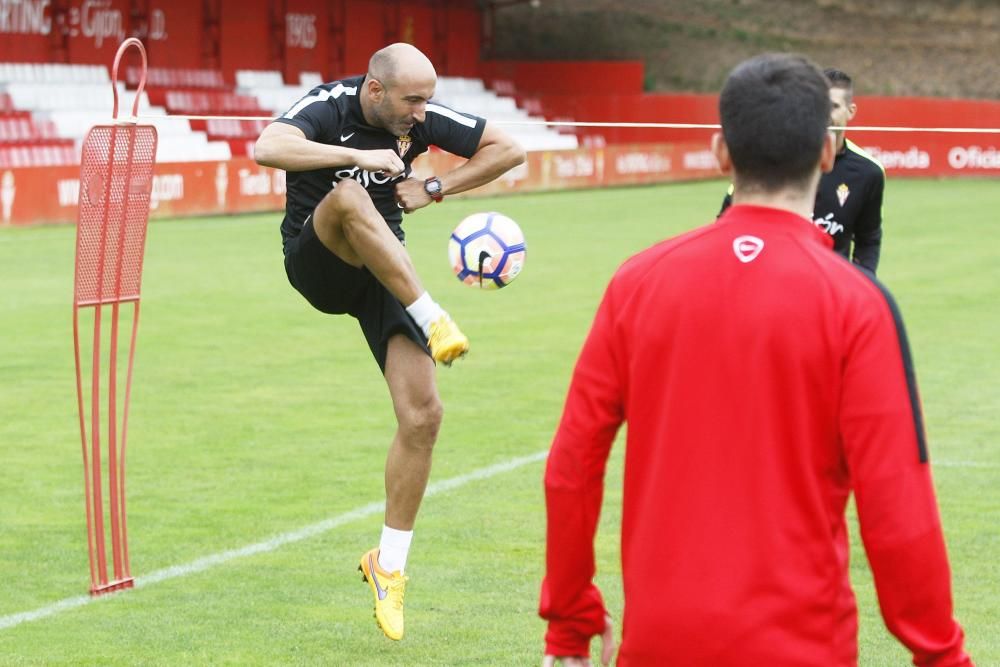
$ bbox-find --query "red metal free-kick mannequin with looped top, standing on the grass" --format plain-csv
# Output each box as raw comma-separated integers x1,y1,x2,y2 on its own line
73,38,157,595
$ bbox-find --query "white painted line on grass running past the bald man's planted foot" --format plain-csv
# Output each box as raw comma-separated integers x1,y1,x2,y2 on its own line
0,450,548,630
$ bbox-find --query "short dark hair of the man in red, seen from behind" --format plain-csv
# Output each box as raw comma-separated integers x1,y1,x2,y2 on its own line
719,53,830,192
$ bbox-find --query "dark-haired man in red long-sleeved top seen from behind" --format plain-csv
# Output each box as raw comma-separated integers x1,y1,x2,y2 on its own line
539,54,972,667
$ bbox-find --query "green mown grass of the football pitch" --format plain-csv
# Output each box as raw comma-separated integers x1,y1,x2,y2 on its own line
0,179,1000,665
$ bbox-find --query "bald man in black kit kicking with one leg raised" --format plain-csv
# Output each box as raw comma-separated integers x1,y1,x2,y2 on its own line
254,43,524,640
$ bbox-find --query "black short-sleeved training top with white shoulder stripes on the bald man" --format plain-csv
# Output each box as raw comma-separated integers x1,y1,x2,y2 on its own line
275,76,486,241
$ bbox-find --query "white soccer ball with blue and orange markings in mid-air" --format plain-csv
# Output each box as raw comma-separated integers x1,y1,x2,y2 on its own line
448,212,527,289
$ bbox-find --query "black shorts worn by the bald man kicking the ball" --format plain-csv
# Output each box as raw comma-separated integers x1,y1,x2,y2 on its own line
284,216,430,373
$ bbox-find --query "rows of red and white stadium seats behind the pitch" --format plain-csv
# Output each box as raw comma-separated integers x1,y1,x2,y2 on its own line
0,63,578,166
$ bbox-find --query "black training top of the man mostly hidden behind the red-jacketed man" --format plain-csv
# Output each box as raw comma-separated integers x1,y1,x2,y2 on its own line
720,140,885,273
